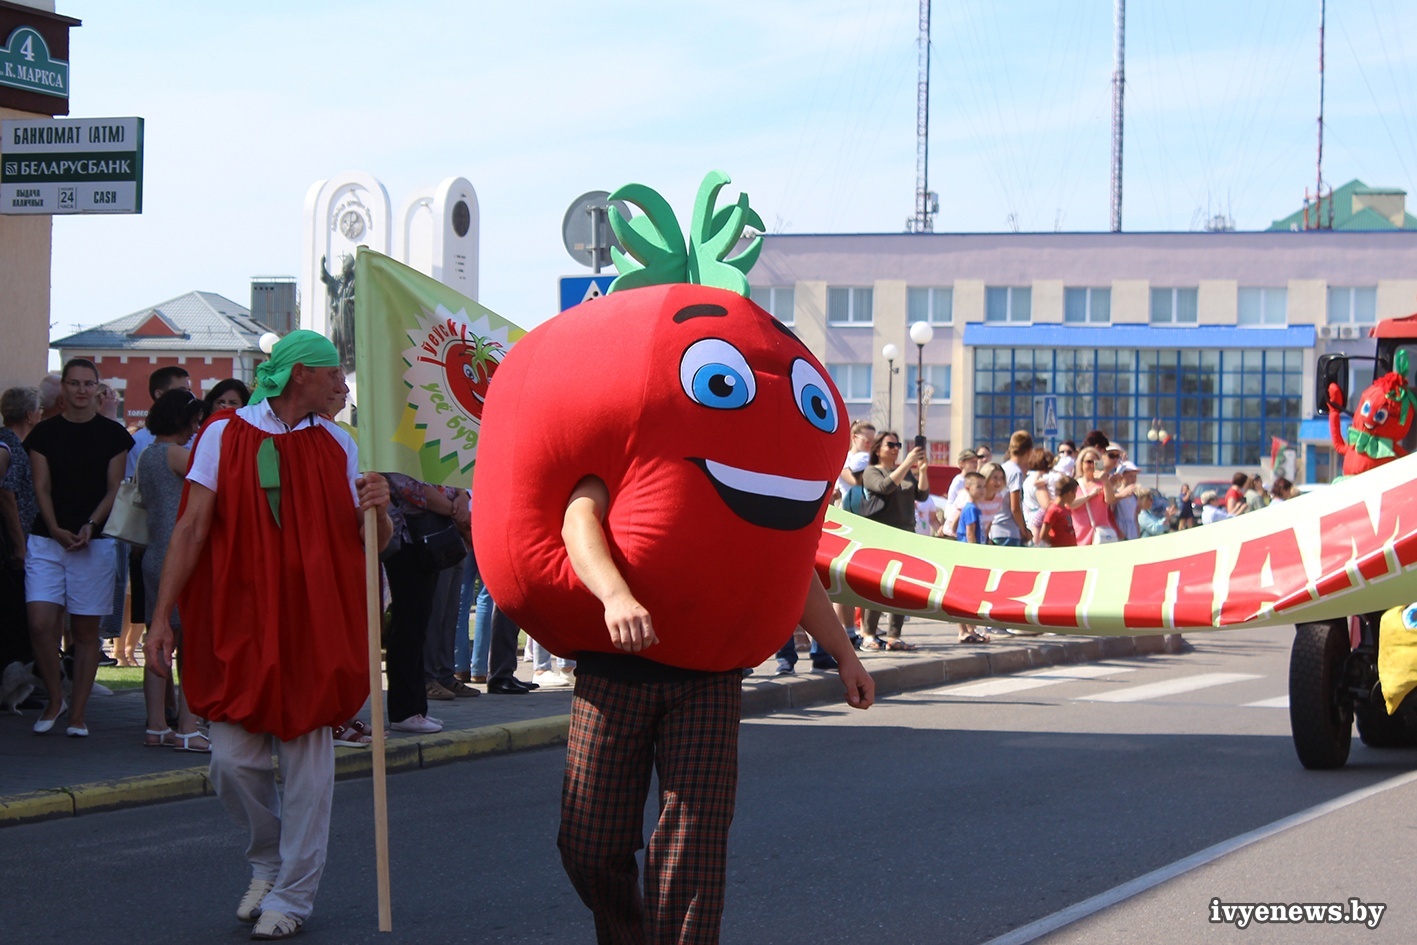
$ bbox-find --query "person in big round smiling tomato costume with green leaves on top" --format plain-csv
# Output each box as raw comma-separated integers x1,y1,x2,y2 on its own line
473,171,874,942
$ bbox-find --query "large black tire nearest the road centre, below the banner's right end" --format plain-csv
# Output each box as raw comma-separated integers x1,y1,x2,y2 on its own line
1289,621,1353,769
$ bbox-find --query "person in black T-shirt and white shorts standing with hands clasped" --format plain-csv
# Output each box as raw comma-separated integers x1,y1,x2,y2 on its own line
24,358,133,738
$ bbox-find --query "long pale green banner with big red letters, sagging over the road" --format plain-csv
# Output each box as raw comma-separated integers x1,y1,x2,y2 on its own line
816,456,1417,635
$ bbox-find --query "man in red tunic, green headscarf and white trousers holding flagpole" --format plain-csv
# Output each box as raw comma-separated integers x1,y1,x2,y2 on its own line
145,330,393,939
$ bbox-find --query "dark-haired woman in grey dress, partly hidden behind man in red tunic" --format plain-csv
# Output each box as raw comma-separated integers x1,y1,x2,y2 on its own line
135,388,211,754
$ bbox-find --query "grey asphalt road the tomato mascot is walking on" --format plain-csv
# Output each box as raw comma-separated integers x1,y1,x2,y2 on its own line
0,630,1417,945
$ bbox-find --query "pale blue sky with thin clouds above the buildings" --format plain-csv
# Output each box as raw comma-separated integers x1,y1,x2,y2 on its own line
44,0,1417,337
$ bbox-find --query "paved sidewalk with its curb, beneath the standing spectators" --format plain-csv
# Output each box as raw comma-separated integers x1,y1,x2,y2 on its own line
0,621,1185,827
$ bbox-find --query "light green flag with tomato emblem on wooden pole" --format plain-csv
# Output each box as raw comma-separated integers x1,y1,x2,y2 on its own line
354,247,526,487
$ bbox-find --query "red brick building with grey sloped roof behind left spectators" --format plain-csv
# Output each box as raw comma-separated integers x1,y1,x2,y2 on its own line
50,292,269,428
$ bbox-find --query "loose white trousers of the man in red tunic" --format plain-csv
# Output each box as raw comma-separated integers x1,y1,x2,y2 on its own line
210,723,334,922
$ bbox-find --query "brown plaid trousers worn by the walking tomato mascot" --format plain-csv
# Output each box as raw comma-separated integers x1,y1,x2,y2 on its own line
557,672,743,945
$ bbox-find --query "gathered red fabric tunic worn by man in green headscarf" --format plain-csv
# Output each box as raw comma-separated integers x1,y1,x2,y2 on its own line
177,417,368,741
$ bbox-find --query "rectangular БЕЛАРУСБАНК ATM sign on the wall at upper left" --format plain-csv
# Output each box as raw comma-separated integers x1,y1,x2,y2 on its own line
0,118,143,214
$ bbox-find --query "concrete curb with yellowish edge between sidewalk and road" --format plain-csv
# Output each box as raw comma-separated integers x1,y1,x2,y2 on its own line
0,633,1189,829
